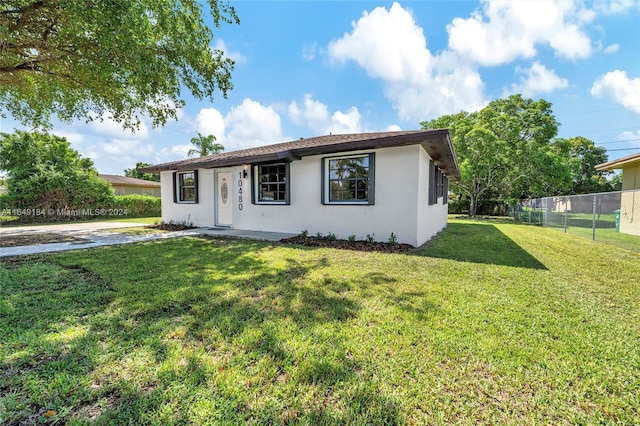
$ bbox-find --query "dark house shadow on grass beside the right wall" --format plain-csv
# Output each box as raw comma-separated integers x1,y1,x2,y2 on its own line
413,223,547,269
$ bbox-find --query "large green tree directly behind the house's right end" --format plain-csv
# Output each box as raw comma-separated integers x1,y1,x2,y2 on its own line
420,95,570,216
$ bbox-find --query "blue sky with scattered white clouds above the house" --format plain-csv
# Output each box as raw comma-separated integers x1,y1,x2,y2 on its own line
0,0,640,174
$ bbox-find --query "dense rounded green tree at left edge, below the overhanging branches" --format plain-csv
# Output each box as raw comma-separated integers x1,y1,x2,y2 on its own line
0,130,113,216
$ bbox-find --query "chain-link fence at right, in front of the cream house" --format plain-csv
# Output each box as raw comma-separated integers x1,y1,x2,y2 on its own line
510,190,640,252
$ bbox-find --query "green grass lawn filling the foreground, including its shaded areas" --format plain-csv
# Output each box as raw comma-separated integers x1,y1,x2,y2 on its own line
0,220,640,425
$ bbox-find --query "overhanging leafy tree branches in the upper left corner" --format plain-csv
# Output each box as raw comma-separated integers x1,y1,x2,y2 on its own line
0,0,239,129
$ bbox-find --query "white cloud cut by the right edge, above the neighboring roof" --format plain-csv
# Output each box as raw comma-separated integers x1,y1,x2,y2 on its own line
591,70,640,114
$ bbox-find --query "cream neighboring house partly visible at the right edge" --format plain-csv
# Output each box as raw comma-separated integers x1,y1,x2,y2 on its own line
596,153,640,235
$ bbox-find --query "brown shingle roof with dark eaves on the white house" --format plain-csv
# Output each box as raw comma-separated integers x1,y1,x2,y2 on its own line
140,129,460,180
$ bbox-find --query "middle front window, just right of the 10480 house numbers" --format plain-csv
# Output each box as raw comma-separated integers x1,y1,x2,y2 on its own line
253,163,289,204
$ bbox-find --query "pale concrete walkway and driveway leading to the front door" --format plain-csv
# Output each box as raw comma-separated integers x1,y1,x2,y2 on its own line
0,222,295,257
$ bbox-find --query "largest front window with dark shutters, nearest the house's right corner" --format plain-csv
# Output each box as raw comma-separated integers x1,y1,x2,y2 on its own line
322,153,375,204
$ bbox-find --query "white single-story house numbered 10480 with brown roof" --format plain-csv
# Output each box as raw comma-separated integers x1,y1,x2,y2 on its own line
140,130,460,246
